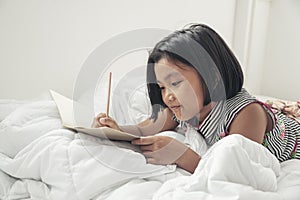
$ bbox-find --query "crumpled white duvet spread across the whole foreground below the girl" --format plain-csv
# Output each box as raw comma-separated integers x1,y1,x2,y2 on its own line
0,101,300,200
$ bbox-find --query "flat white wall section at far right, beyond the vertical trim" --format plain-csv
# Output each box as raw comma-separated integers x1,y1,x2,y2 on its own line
261,0,300,101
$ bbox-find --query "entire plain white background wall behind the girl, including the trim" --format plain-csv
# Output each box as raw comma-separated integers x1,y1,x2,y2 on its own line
0,0,300,100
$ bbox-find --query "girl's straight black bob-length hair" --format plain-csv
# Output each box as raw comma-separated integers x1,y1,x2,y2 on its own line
147,24,244,120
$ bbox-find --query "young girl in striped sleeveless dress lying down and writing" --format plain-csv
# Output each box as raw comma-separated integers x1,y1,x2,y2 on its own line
93,24,300,173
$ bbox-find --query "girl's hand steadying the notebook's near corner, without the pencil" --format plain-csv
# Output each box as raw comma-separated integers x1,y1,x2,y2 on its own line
131,136,188,165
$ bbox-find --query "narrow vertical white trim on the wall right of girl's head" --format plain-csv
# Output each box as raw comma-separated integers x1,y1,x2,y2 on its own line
236,0,271,94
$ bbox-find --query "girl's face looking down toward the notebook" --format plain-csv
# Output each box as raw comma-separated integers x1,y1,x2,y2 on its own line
154,58,204,121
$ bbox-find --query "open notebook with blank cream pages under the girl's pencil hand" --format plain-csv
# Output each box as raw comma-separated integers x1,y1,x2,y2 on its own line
50,90,139,141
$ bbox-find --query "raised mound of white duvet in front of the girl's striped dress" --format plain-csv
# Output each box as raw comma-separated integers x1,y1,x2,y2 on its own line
154,134,281,200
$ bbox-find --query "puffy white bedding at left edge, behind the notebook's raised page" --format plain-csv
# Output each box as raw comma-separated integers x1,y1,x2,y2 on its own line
0,100,61,157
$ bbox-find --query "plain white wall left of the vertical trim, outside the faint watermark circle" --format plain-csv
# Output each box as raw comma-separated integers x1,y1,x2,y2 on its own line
0,0,235,99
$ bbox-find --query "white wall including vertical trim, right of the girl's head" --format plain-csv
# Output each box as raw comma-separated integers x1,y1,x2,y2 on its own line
241,0,300,101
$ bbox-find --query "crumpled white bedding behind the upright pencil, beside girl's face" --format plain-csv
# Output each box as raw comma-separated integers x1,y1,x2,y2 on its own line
92,77,151,125
